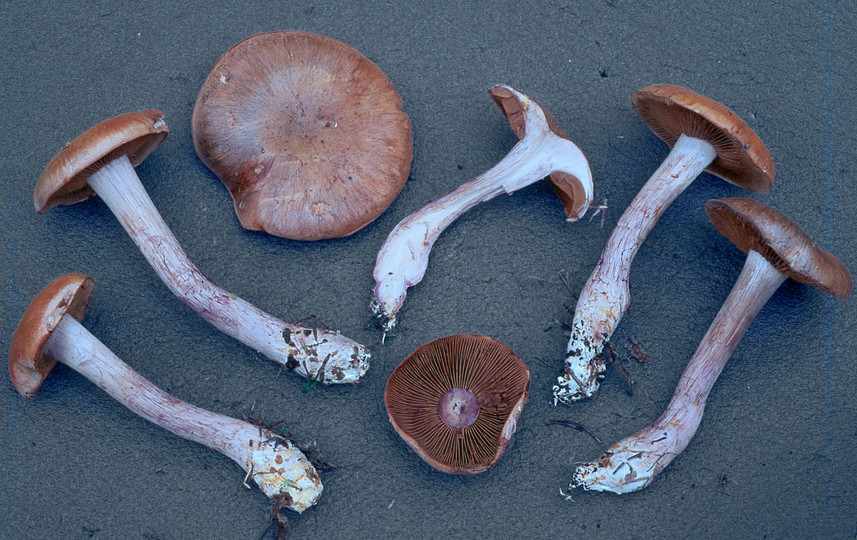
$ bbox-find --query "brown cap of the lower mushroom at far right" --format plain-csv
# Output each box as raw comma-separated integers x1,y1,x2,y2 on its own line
705,197,851,298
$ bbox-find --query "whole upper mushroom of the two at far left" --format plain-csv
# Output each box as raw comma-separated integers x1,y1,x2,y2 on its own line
33,110,369,384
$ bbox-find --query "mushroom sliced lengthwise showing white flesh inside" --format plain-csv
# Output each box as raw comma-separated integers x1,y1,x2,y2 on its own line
371,85,592,335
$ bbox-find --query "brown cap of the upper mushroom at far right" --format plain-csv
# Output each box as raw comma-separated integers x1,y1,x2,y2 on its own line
631,84,774,193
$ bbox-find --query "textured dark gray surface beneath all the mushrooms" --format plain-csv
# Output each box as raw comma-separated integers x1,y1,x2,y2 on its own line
0,0,857,539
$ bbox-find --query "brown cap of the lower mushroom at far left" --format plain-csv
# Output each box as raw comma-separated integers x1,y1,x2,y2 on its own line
9,274,95,397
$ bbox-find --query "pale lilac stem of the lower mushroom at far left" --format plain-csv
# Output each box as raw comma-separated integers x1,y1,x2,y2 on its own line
45,315,322,512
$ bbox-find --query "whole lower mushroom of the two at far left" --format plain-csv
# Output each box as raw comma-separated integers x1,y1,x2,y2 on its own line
9,274,322,512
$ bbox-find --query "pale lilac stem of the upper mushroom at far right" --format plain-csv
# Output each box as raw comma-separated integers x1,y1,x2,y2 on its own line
553,135,717,405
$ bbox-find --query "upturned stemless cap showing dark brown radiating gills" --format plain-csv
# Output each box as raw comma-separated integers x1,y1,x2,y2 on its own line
384,335,530,474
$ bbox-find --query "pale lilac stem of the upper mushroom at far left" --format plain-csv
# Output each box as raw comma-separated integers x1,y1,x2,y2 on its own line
87,155,369,384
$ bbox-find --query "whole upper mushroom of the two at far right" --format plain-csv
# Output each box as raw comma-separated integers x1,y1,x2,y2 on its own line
553,84,774,405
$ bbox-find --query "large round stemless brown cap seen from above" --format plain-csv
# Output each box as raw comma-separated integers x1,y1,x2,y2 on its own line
192,32,413,240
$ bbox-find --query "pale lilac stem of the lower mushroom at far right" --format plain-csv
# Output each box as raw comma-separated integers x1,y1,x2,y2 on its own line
570,251,786,493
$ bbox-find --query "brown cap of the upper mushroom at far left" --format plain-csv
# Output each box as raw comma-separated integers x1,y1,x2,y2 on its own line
33,109,170,213
